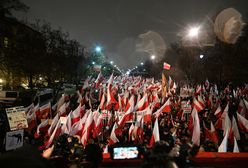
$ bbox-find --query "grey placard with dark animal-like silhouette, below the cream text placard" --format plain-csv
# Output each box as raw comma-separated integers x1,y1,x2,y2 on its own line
5,129,24,151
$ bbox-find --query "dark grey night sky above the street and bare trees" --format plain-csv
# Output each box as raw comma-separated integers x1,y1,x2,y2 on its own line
18,0,248,68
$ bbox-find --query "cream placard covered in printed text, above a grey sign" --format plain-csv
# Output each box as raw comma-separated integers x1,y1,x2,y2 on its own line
5,106,28,131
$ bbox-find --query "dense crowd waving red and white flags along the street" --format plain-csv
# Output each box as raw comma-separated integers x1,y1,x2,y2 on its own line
1,74,248,167
